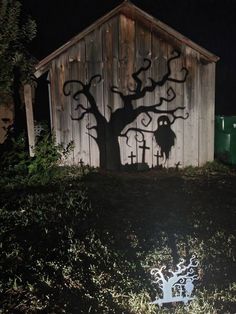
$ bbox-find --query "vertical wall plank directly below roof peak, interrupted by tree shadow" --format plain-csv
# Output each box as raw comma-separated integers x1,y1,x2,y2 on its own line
118,15,137,165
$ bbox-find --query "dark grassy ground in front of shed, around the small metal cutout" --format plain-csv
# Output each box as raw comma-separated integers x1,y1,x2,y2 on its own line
0,164,236,314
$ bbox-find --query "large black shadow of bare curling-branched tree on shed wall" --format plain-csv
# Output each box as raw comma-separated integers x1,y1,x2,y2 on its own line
63,51,188,170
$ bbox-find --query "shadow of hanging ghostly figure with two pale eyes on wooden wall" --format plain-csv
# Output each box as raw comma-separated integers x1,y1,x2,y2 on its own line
154,116,176,160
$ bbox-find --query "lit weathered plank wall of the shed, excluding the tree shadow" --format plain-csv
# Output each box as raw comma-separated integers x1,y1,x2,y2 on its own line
49,15,215,167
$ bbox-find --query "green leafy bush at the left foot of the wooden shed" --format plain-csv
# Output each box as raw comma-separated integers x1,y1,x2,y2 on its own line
0,130,73,184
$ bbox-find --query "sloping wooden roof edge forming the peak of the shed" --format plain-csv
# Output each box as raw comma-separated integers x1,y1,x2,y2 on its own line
35,0,219,77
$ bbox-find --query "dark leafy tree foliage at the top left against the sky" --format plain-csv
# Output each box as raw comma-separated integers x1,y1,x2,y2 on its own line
0,0,36,100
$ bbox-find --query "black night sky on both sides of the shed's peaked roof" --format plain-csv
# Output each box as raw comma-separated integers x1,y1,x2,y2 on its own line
21,0,236,115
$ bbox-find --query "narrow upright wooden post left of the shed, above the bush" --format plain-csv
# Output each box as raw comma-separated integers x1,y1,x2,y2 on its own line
24,83,35,157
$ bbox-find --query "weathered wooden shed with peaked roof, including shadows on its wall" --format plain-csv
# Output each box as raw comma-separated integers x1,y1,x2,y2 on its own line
25,1,218,170
